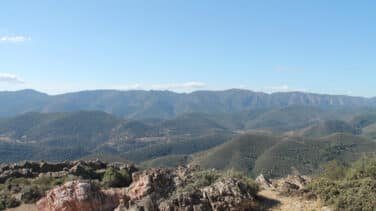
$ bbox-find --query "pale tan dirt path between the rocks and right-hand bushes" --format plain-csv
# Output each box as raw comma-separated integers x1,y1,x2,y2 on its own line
259,190,330,211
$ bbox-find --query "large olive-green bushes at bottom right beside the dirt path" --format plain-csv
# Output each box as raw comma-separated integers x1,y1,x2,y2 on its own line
308,156,376,211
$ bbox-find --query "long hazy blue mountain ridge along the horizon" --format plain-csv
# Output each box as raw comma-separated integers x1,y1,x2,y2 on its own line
0,89,376,119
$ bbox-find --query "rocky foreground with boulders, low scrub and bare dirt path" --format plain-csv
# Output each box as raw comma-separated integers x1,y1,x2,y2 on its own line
0,160,328,211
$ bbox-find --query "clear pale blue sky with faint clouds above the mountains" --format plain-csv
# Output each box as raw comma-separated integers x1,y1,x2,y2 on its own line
0,0,376,97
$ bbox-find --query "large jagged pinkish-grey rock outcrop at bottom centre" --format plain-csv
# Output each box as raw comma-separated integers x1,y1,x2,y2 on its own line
38,167,262,211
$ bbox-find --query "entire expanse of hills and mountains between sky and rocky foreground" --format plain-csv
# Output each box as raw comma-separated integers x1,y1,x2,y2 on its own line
0,89,376,177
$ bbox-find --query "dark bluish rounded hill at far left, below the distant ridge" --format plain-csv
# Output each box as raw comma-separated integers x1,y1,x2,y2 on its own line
0,111,119,148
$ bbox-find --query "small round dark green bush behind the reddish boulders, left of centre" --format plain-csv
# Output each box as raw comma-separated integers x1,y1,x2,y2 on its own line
102,168,132,187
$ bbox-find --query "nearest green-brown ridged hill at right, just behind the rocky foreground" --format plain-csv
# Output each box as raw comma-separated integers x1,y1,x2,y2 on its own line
190,133,376,177
